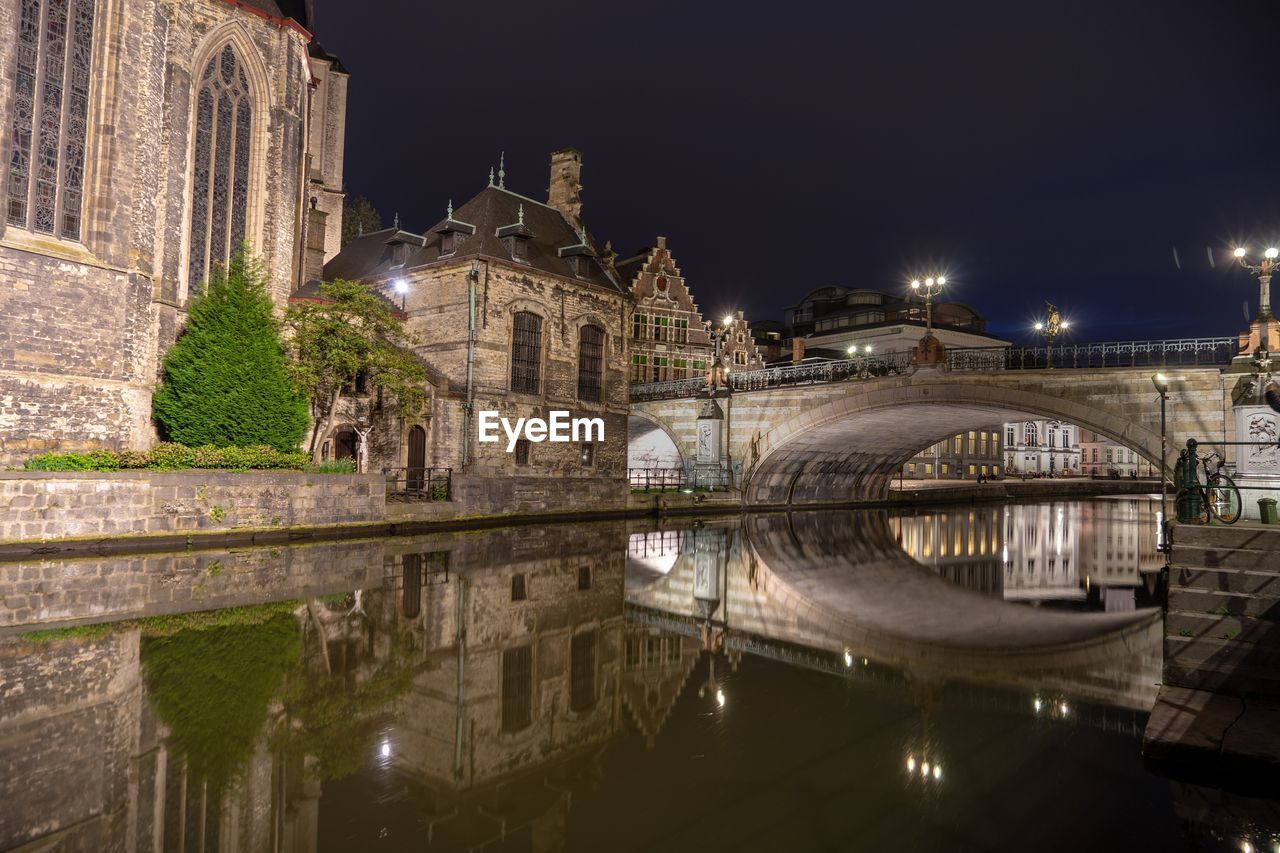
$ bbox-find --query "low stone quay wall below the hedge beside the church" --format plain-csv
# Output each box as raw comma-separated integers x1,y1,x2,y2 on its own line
0,470,387,542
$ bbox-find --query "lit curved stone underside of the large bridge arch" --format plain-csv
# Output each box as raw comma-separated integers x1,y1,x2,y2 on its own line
742,371,1175,505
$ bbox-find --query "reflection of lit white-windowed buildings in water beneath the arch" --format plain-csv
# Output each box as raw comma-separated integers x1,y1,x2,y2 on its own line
890,497,1164,611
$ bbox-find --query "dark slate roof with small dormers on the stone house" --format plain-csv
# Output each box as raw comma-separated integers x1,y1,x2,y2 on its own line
324,186,627,293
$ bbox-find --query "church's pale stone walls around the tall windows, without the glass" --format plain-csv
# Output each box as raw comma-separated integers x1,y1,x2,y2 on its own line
0,0,346,464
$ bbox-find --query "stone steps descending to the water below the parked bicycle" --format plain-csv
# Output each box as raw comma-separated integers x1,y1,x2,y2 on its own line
1164,524,1280,697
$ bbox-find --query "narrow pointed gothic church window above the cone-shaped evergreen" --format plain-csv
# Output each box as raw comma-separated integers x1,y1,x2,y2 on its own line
187,45,253,288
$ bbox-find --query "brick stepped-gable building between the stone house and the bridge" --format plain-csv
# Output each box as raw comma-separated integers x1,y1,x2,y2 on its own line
616,237,764,383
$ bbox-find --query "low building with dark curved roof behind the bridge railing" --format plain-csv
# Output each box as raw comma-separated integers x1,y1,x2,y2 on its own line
786,286,1010,356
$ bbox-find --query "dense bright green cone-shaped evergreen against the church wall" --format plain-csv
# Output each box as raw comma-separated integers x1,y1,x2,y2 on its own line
152,251,307,451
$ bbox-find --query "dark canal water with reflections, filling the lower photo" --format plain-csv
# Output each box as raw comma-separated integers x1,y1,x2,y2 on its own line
0,497,1280,852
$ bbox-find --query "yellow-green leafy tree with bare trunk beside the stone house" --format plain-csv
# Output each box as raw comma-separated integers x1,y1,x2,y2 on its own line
285,279,426,455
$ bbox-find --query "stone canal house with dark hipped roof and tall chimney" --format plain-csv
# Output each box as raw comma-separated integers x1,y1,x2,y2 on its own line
320,149,630,508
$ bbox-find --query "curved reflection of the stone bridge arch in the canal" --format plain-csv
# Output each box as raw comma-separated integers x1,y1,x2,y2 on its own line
627,511,1162,708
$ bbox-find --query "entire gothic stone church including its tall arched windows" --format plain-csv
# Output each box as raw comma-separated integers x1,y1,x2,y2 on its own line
0,0,347,465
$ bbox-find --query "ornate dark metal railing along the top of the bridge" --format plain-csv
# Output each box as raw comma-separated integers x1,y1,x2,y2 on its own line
631,338,1239,402
